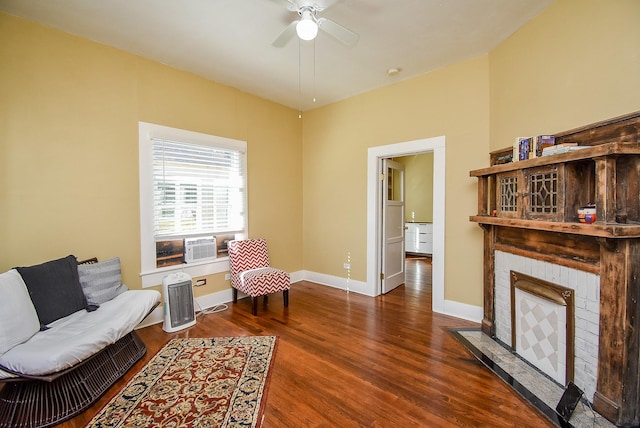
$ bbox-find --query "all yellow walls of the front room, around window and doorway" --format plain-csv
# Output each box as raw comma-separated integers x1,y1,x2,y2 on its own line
0,0,640,306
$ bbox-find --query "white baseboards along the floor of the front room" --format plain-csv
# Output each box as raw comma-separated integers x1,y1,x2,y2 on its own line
136,270,483,328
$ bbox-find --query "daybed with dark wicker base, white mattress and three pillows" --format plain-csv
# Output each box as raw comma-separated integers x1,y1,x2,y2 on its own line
0,256,160,428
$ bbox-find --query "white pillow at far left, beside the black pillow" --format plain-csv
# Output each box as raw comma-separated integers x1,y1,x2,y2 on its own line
0,269,40,355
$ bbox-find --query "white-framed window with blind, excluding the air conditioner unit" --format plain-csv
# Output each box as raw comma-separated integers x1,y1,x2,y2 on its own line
139,122,247,287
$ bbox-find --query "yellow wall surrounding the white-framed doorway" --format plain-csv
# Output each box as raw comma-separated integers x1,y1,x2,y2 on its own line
303,56,489,305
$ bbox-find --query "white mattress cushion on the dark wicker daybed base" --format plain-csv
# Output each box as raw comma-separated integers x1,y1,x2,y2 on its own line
0,290,160,379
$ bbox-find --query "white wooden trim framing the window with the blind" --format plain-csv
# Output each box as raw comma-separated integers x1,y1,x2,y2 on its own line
138,122,248,288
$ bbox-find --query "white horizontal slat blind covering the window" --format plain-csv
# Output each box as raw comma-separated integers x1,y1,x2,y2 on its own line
151,138,246,241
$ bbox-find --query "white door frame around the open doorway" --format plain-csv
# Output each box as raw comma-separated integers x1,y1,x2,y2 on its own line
366,136,445,313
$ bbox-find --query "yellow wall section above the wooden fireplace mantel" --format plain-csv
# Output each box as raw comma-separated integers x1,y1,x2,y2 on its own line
489,0,640,150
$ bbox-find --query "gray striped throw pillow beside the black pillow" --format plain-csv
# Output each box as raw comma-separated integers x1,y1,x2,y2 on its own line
78,257,128,306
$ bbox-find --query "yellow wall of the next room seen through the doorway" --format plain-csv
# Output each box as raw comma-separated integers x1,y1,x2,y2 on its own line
393,153,433,223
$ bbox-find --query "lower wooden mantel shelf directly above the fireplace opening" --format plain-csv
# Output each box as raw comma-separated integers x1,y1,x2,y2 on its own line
469,215,640,238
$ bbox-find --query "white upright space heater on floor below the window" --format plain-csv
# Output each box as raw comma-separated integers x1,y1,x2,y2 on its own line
162,272,196,333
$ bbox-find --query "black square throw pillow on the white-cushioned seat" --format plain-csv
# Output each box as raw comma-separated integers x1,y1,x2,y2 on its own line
16,256,87,328
